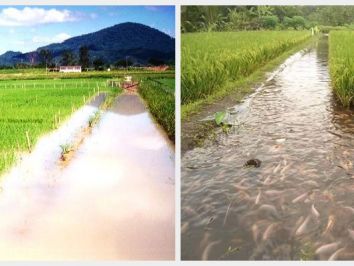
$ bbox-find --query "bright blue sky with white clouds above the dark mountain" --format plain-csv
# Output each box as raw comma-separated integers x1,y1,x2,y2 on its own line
0,6,175,54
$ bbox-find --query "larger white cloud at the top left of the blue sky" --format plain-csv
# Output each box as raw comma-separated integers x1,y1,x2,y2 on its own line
0,7,77,26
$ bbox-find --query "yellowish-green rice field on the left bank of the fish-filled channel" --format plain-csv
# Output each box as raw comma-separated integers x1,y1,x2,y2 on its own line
181,31,311,104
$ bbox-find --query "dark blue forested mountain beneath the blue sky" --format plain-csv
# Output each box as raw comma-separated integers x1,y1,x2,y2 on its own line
0,22,175,66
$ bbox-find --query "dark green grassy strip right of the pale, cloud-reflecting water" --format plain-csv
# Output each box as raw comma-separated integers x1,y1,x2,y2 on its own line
139,78,175,142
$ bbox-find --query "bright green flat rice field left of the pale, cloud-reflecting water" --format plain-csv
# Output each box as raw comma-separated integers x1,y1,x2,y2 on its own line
0,79,108,173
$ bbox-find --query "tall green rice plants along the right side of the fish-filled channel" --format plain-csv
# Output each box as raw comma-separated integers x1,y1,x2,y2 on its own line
329,31,354,107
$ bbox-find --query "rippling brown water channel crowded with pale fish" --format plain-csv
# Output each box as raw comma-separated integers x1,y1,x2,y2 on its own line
181,39,354,260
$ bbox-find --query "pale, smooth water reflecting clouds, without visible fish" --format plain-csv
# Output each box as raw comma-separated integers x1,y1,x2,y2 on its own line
0,92,175,260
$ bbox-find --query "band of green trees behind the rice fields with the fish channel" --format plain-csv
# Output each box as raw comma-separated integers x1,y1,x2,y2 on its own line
181,6,354,32
